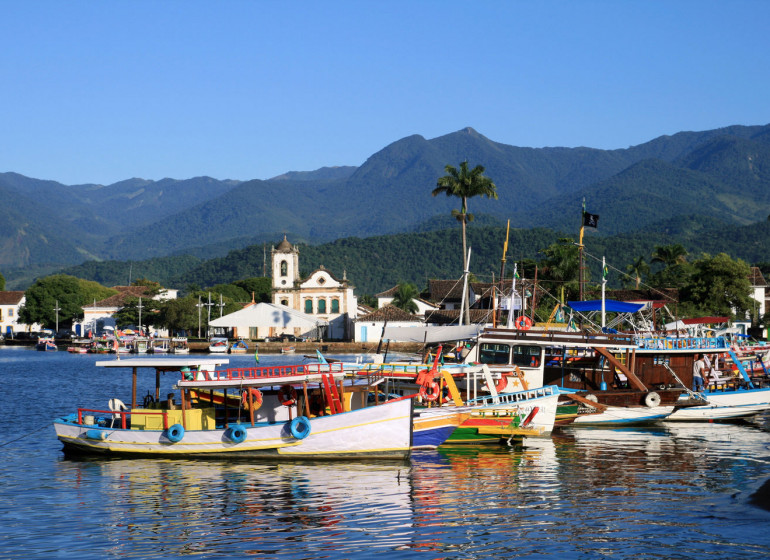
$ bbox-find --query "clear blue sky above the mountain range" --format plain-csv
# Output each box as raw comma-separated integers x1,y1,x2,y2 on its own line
0,0,770,184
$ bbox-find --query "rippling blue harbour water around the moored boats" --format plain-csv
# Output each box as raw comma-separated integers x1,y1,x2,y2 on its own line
0,347,770,560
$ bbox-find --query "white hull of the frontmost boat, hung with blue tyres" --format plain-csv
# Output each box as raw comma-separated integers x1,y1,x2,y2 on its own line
54,399,412,460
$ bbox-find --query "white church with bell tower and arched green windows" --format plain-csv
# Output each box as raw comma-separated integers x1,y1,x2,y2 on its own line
271,236,358,340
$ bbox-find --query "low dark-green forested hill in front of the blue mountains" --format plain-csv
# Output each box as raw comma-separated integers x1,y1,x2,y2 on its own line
52,216,770,295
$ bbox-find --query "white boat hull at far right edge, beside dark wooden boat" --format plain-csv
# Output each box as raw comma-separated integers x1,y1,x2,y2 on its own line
666,389,770,422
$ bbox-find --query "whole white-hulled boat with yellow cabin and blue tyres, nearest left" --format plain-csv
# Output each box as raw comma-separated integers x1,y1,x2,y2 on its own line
54,358,413,460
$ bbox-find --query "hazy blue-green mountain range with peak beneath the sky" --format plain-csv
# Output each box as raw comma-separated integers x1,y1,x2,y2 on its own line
0,125,770,283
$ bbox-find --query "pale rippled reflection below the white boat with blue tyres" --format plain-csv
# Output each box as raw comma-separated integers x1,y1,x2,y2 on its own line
56,460,413,554
